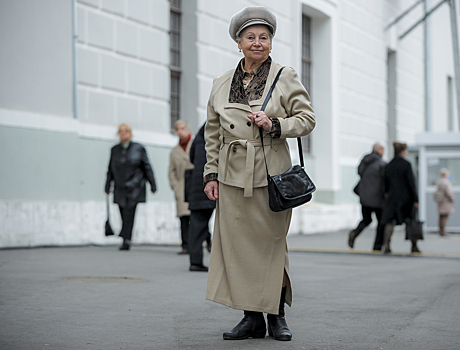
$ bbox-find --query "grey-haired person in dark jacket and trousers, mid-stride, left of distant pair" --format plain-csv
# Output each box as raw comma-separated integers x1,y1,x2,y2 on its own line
348,142,386,251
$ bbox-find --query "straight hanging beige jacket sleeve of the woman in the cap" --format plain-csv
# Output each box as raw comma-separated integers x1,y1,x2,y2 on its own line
203,79,220,176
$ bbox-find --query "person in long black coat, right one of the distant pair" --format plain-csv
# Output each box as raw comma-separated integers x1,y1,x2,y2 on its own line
381,142,420,253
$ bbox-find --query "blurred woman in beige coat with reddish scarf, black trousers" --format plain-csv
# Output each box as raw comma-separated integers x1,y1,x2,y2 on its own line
169,120,193,254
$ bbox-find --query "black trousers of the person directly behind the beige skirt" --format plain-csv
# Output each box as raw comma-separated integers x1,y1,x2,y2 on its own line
188,209,214,266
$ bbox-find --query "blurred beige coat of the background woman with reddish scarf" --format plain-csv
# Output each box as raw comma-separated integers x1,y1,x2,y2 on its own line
168,136,193,218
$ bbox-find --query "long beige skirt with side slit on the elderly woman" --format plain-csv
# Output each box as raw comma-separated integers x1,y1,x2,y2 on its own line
206,183,292,315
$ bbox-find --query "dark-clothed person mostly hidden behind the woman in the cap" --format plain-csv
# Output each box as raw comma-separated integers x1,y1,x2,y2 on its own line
188,124,216,272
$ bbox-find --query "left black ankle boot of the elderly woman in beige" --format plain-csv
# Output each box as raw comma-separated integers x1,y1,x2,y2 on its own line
224,311,267,340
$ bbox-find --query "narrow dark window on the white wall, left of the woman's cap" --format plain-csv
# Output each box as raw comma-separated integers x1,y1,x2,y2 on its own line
169,0,181,128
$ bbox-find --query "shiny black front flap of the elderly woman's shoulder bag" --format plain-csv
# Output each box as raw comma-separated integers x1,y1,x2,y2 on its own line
271,165,316,199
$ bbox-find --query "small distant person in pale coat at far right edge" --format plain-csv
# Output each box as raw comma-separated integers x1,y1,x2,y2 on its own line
434,168,455,236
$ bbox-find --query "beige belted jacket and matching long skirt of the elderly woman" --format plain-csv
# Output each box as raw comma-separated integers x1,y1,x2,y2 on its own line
204,62,315,314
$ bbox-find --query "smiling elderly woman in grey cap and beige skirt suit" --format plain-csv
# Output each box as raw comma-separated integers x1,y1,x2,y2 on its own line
204,6,315,340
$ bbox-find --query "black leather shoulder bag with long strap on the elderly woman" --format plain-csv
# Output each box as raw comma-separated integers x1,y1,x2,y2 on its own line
259,67,316,212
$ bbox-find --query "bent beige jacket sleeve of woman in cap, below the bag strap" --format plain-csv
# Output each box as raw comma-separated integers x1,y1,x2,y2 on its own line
274,67,316,138
